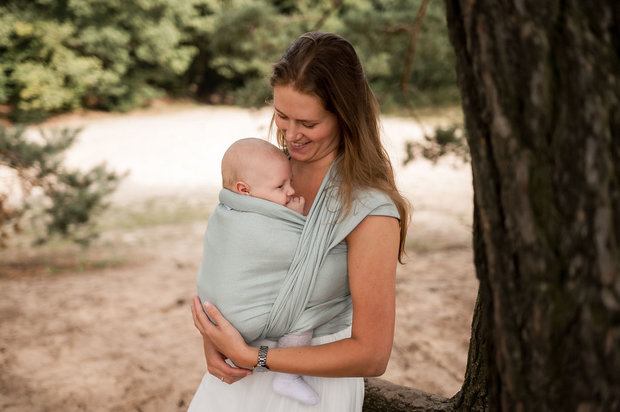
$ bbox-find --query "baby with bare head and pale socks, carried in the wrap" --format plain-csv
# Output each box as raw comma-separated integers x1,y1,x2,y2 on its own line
207,138,319,405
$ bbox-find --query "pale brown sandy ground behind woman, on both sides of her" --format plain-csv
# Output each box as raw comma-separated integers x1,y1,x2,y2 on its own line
0,106,477,411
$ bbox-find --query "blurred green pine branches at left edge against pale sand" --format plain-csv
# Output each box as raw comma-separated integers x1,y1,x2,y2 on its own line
0,127,122,246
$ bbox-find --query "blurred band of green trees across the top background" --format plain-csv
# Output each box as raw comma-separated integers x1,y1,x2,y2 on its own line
0,0,458,122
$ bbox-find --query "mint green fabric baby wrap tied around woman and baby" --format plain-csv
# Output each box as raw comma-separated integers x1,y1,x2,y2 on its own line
196,169,399,343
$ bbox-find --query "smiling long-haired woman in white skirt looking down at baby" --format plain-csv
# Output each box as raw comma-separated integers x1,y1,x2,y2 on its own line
190,32,409,411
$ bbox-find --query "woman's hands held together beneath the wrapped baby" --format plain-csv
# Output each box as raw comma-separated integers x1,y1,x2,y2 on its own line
191,297,256,383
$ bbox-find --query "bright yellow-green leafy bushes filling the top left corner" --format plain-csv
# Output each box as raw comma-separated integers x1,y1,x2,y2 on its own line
0,0,204,120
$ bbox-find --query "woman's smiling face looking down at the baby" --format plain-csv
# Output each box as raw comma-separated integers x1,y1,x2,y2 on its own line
273,85,340,163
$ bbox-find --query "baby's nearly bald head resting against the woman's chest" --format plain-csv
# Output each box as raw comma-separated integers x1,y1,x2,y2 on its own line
222,137,295,206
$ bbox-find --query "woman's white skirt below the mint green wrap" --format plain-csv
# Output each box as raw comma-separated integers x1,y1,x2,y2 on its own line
188,328,364,412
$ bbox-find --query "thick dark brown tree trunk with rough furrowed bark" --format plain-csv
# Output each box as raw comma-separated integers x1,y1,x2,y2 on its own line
367,0,620,411
